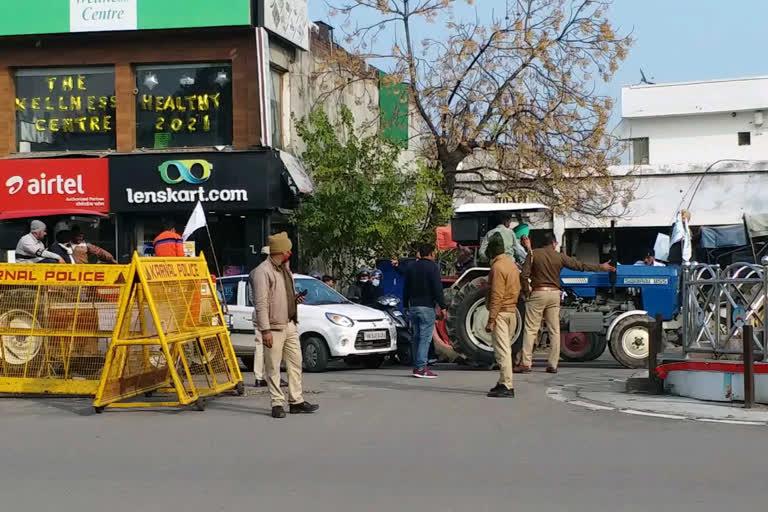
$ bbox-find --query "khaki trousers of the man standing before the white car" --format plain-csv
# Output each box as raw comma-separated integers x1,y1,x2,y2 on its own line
262,322,304,407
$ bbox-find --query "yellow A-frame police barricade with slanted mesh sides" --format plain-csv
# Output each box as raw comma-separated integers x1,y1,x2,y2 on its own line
94,255,243,411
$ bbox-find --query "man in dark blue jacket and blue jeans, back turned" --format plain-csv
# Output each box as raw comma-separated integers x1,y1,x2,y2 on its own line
393,244,445,379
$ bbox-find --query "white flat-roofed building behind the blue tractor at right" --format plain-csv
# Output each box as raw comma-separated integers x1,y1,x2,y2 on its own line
565,77,768,266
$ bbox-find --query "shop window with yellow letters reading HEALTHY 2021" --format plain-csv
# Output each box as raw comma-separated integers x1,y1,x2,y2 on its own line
136,64,232,149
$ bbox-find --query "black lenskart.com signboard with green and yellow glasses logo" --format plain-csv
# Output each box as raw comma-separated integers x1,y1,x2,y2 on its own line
109,152,282,213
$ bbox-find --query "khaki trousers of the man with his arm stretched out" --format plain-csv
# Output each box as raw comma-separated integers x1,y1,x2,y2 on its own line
520,290,560,368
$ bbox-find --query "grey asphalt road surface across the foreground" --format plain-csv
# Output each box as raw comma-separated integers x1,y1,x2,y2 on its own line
0,361,766,512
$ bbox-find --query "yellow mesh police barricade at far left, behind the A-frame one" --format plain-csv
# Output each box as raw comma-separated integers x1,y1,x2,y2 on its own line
0,263,133,395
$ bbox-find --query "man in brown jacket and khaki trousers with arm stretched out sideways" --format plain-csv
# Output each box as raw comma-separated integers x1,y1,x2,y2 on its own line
515,231,616,373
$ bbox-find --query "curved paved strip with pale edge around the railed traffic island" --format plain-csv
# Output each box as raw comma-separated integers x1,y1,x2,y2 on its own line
547,372,768,426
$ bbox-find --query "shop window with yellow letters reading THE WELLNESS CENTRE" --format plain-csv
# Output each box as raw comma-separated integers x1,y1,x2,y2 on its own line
15,67,117,153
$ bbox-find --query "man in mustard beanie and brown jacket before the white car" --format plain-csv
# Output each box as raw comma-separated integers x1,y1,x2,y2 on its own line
251,232,319,418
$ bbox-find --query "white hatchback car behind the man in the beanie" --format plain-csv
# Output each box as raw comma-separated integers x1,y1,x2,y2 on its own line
218,274,397,372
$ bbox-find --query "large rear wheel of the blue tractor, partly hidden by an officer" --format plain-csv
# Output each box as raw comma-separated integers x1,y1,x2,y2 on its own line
447,279,525,366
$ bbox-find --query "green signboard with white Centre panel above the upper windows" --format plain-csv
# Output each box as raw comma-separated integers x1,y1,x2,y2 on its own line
0,0,251,36
